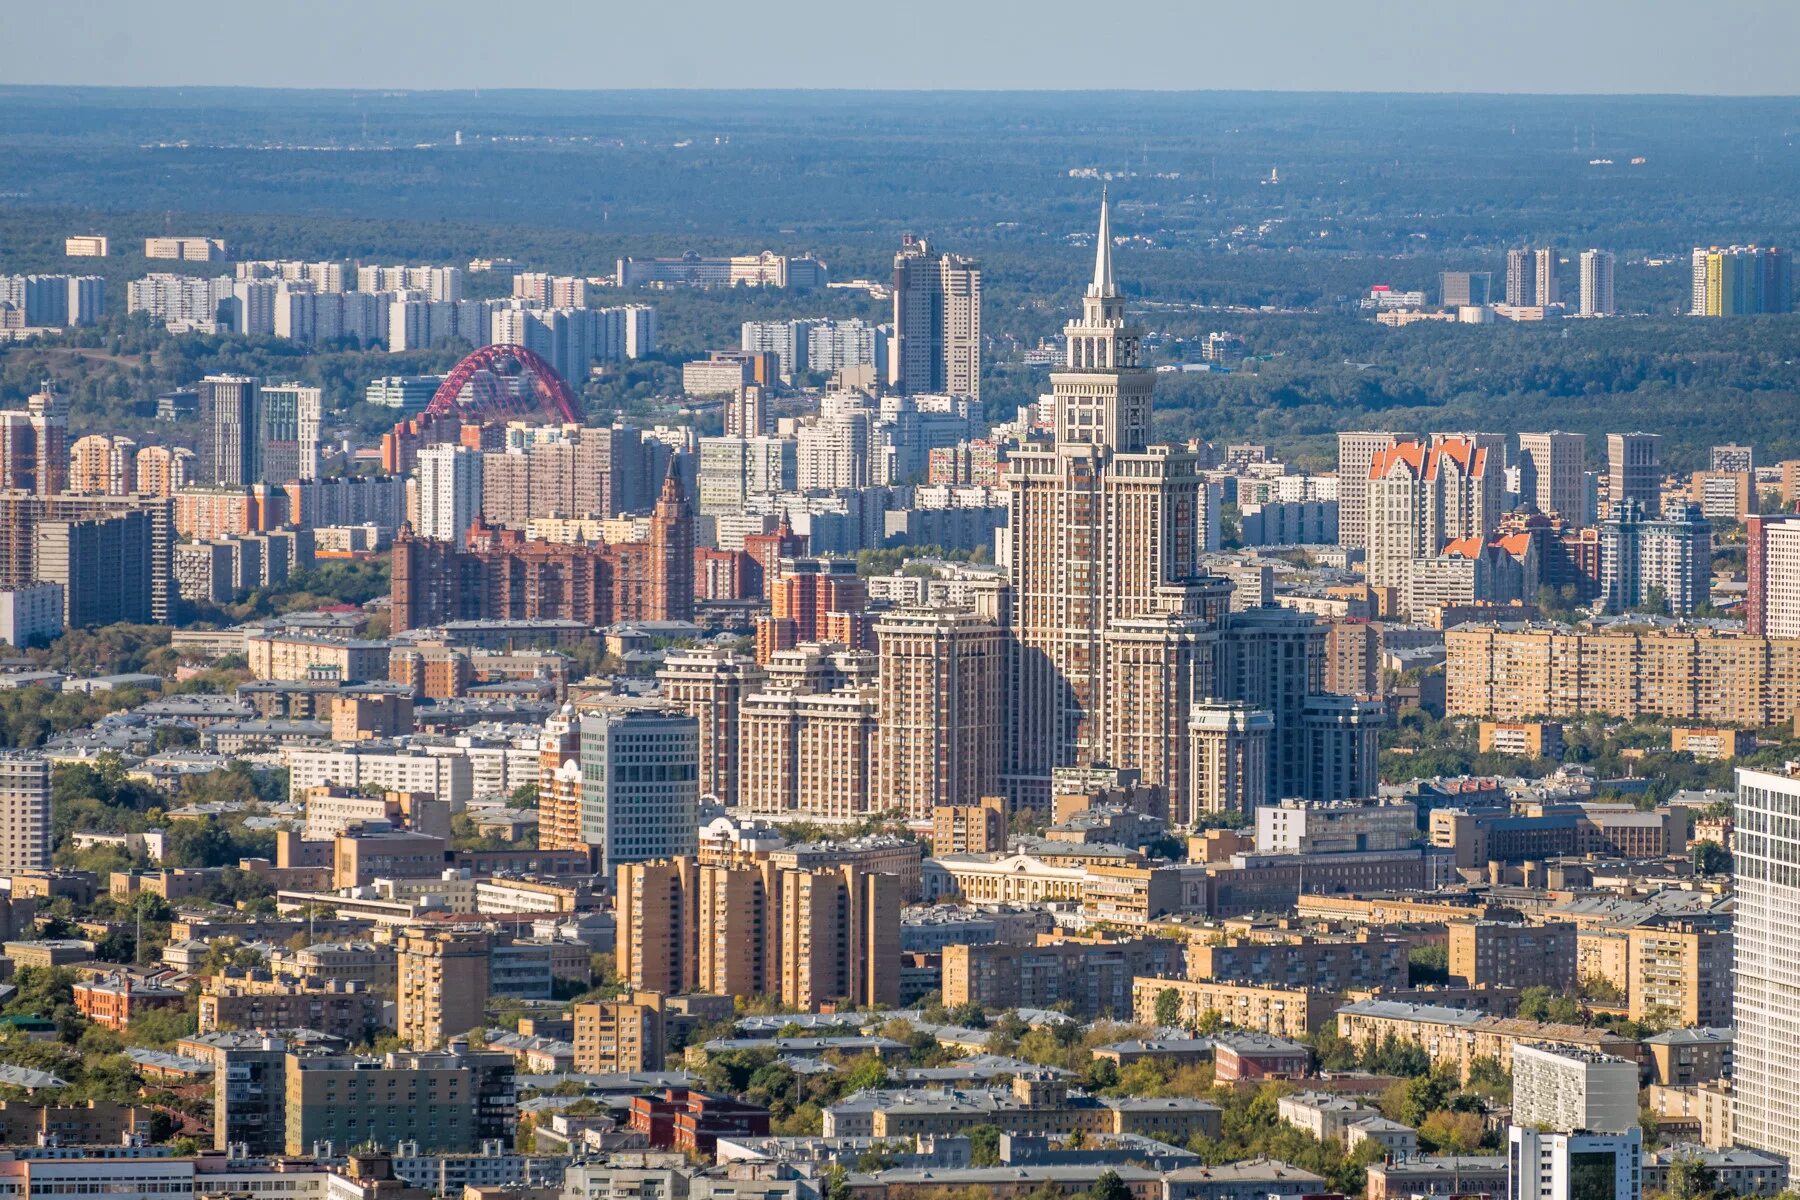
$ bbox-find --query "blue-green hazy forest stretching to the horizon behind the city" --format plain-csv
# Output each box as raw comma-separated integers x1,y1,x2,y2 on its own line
0,88,1800,468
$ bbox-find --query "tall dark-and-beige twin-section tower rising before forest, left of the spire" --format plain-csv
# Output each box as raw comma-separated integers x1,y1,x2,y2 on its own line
887,234,986,399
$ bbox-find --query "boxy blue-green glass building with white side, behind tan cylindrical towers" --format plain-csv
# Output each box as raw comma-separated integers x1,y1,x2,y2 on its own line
580,700,700,874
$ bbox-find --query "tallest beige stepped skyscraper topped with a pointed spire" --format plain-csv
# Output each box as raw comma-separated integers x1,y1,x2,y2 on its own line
1004,196,1211,804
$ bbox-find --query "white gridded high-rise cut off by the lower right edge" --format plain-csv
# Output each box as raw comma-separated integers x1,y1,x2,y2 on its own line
1732,768,1800,1162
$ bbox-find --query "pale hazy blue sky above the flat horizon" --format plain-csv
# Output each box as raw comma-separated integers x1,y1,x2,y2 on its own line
0,0,1800,94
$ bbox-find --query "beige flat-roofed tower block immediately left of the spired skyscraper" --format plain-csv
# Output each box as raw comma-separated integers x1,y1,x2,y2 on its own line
875,608,1006,819
